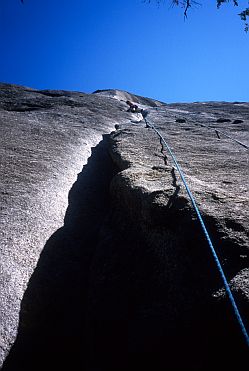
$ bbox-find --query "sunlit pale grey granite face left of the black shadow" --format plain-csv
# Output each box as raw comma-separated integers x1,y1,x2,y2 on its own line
0,84,132,364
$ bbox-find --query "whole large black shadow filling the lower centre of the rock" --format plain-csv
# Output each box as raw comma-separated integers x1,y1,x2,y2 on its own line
3,132,246,371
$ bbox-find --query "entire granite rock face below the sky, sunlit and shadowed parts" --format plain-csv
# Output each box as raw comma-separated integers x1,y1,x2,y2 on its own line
0,84,249,370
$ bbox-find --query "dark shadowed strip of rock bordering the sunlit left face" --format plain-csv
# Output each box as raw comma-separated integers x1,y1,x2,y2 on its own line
3,136,118,371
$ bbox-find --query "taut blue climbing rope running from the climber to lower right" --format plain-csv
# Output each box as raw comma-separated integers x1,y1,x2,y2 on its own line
144,118,249,347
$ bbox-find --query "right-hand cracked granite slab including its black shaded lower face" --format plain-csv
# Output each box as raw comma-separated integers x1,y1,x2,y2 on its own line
88,102,249,370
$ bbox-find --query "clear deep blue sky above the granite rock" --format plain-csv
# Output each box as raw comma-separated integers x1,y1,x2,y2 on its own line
0,0,249,102
